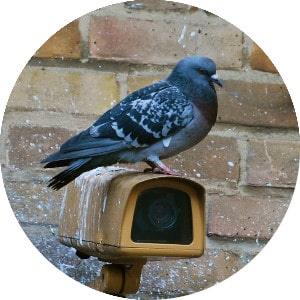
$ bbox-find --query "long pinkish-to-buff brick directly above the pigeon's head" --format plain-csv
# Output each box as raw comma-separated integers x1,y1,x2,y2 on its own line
90,16,242,69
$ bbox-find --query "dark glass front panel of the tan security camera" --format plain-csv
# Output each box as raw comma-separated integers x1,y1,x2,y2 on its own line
131,187,193,245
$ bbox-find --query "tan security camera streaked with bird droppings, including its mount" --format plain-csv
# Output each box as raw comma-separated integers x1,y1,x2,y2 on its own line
58,167,205,295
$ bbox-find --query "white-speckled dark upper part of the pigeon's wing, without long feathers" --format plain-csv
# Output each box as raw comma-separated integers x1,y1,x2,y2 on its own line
90,81,193,148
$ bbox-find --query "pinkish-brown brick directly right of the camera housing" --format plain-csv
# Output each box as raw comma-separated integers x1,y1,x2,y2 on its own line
208,195,289,241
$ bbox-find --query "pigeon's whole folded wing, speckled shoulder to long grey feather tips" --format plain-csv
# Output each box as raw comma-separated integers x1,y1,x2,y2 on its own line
42,81,193,162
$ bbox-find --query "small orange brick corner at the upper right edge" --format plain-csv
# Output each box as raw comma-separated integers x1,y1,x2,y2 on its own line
249,44,278,73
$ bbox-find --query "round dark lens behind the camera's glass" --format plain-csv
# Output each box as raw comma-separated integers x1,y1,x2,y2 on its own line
148,199,177,230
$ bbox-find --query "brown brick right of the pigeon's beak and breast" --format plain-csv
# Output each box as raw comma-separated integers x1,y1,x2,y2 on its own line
218,80,298,128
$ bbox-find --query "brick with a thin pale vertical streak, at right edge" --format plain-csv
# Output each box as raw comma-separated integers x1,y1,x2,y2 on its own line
247,139,300,187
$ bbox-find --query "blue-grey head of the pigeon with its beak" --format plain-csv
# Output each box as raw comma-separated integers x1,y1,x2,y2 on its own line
167,56,222,98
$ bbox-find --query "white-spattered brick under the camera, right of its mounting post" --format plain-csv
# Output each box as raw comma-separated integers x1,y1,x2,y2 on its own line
139,250,243,297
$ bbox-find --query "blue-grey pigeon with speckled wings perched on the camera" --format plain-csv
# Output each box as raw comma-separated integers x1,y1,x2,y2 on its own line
41,56,222,190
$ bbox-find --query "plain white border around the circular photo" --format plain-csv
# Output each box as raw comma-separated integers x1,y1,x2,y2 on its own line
0,0,300,300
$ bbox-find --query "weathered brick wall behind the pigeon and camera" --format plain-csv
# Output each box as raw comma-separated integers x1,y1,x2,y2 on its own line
0,0,299,296
